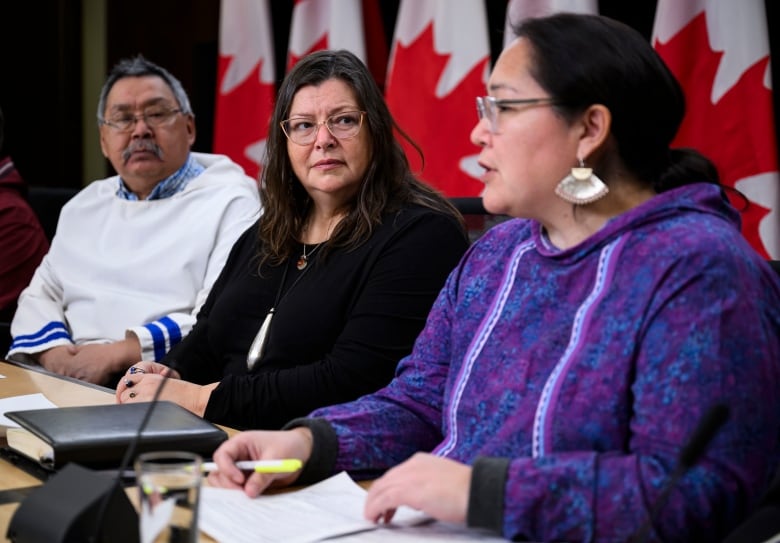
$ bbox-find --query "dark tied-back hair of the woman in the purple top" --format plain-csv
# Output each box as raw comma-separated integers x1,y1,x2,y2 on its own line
513,13,720,196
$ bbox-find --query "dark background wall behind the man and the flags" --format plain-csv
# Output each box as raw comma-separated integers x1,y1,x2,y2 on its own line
0,0,780,187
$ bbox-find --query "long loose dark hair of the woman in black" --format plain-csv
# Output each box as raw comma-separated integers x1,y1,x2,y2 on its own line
258,50,463,264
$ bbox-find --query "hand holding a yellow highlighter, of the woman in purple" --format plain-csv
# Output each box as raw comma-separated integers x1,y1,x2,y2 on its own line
208,427,314,498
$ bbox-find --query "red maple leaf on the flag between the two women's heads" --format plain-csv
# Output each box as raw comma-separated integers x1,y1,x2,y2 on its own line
385,24,488,196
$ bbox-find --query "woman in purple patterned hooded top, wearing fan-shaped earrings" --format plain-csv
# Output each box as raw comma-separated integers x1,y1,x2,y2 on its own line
203,14,780,542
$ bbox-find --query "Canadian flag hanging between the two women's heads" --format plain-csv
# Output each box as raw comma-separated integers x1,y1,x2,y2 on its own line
385,0,490,196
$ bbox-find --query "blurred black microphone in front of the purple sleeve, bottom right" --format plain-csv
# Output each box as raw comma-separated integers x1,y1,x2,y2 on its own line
629,403,729,543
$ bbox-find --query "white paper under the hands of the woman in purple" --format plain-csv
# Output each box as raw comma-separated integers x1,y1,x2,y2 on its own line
199,472,458,543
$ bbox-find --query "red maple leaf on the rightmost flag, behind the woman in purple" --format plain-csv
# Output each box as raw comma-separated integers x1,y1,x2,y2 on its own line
655,13,778,258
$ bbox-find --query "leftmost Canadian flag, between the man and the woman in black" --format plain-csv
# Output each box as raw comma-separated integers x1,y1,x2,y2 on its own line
213,0,276,183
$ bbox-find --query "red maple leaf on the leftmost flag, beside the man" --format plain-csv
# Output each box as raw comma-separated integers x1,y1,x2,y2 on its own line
213,56,275,179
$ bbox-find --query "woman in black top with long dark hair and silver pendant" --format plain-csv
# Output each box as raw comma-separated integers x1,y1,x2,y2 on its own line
116,51,468,429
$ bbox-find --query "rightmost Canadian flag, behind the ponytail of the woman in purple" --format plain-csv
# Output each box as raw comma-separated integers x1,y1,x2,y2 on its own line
652,0,780,259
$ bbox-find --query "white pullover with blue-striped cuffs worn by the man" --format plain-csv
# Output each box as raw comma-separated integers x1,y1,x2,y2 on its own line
6,153,261,360
